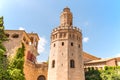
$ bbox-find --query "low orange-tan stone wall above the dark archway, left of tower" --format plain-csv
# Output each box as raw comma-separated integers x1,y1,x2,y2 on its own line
24,61,48,80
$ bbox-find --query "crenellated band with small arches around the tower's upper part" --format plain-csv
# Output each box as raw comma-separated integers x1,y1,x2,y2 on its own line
51,26,82,42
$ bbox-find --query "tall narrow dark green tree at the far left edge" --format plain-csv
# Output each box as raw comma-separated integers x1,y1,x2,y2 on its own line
0,17,8,80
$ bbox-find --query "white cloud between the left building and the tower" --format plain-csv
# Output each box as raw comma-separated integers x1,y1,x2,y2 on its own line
38,37,47,54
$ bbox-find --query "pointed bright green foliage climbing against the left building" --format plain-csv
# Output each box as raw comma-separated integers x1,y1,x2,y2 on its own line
8,43,25,80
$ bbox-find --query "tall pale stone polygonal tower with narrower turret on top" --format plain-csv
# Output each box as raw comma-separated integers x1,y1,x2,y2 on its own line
48,7,85,80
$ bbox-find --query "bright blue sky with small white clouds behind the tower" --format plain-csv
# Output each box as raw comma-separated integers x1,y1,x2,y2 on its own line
0,0,120,61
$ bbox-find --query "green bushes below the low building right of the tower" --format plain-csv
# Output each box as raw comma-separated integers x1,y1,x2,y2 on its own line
85,66,120,80
